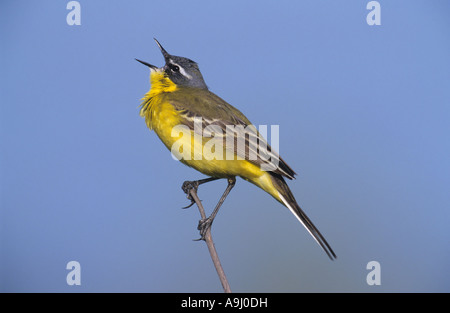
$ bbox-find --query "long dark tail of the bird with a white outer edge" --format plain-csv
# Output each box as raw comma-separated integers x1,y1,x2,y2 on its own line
271,173,336,260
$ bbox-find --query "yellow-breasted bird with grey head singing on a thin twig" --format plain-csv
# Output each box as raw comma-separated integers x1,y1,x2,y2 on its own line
136,39,336,259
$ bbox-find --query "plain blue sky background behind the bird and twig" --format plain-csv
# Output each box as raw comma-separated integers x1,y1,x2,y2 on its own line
0,0,450,292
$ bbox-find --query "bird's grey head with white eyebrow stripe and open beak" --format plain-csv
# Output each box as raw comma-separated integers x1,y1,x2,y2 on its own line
136,38,208,89
